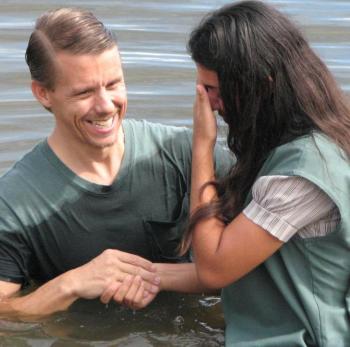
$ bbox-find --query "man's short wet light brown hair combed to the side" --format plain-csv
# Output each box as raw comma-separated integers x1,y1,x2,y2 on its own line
25,8,117,89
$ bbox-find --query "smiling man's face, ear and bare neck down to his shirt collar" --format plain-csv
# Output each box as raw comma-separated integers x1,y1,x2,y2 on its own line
33,45,127,185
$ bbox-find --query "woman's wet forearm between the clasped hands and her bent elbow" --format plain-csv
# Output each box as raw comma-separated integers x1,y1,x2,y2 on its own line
155,263,212,293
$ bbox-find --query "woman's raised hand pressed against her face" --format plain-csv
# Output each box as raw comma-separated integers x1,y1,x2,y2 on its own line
193,84,217,147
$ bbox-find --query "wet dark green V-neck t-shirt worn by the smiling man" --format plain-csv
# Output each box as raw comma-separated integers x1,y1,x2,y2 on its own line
0,120,232,283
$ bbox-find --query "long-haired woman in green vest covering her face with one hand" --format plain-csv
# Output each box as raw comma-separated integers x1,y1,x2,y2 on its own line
183,1,350,347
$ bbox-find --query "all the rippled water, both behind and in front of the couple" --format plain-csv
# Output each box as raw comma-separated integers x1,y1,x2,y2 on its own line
0,0,350,347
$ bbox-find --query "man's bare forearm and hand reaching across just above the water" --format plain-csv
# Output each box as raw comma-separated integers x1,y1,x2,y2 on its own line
0,250,160,317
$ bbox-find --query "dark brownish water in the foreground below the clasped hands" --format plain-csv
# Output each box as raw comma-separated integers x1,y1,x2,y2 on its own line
0,293,224,347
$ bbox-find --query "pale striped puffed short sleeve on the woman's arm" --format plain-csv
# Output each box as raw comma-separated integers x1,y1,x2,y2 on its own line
243,176,340,242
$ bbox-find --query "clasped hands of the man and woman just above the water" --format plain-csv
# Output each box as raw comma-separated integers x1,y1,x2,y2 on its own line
70,249,160,309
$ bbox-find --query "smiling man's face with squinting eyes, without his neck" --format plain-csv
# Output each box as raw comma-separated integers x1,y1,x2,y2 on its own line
45,47,127,148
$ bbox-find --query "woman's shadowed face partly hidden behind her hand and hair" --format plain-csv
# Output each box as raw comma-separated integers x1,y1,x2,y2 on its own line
197,64,224,115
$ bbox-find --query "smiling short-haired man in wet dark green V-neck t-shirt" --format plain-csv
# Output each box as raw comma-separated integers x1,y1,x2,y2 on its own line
0,9,230,316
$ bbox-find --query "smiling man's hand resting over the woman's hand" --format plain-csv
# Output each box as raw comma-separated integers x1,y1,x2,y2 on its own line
67,249,160,299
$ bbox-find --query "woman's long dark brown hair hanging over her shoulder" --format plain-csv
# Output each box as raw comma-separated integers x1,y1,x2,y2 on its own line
182,1,350,250
